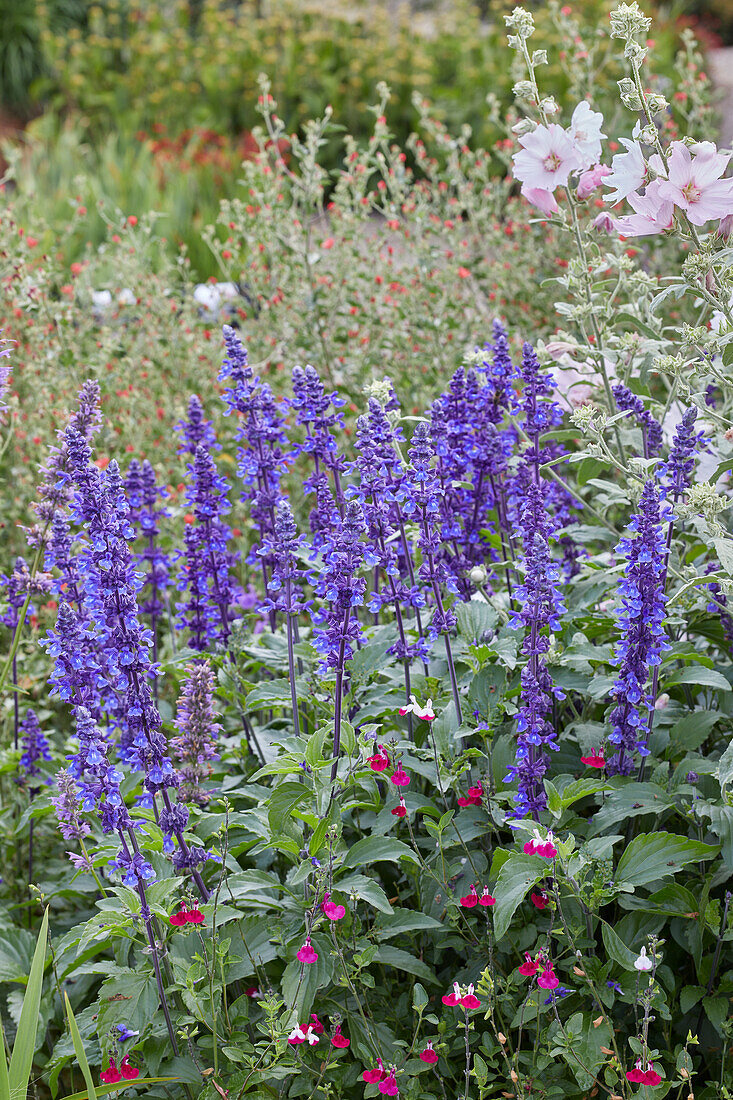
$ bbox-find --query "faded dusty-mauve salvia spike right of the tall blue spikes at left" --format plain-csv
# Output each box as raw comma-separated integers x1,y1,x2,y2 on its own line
171,661,221,806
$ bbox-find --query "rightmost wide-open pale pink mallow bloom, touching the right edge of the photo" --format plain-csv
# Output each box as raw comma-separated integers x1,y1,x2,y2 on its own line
647,141,733,226
